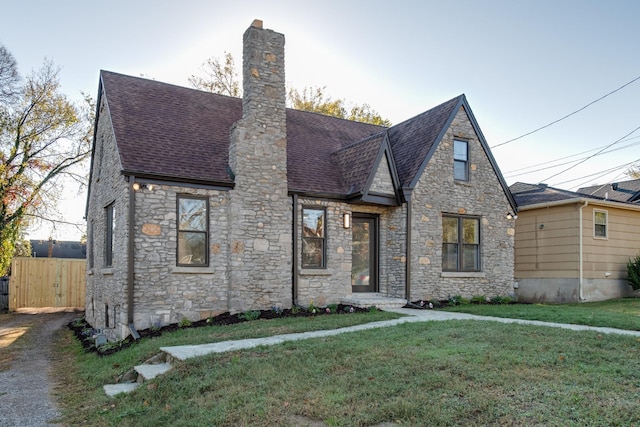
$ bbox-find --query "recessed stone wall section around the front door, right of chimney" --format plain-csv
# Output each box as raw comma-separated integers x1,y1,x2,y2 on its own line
296,198,406,307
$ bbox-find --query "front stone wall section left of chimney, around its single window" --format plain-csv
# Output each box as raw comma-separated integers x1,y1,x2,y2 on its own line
129,185,230,329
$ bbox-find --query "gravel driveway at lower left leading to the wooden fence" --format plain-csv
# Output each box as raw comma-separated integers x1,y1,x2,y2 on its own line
0,309,79,427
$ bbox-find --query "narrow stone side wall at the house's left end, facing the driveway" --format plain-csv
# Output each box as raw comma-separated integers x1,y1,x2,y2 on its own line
85,94,129,337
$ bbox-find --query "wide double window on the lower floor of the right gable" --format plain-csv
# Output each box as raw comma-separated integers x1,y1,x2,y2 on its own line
442,215,480,271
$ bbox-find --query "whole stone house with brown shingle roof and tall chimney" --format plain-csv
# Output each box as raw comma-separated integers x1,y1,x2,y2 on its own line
86,21,516,339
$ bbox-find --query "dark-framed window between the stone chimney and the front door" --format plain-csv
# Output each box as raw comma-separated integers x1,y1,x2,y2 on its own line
302,208,326,268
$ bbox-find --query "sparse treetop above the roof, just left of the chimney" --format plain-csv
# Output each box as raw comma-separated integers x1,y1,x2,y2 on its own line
189,52,241,97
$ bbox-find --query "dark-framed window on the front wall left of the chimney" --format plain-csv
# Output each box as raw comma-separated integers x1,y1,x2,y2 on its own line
177,196,209,267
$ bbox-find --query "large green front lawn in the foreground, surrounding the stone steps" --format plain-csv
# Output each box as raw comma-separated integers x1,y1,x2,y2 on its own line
55,306,640,426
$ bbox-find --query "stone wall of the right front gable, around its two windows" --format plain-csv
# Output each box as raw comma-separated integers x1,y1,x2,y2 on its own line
410,108,515,300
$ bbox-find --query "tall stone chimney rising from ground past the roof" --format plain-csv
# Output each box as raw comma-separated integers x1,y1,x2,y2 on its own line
228,20,292,312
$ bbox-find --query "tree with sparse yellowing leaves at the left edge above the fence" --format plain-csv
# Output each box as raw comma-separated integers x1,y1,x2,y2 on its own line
0,48,91,275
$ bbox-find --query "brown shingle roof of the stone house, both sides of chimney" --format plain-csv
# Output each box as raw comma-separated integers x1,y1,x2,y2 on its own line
101,71,510,205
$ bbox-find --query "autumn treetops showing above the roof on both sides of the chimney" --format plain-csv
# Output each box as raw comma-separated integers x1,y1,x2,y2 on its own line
189,52,391,127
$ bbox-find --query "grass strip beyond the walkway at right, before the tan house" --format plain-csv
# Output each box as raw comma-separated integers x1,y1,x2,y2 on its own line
446,298,640,331
